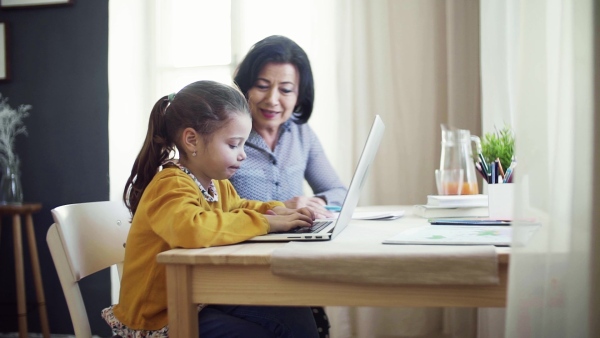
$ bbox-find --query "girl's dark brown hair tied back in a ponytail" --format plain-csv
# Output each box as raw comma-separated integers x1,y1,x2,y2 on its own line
123,81,250,215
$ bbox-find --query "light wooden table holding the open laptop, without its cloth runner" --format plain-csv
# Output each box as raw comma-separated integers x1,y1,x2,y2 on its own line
157,206,509,337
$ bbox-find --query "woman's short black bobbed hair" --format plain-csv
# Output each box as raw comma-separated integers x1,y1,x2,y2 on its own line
234,35,315,124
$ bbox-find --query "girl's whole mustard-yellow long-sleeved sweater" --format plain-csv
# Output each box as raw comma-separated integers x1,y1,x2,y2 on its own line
113,168,283,330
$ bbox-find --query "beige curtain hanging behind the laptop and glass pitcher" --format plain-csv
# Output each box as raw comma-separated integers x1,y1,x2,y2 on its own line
327,0,481,338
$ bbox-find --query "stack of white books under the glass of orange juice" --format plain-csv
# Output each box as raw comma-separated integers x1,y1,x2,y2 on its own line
413,194,489,218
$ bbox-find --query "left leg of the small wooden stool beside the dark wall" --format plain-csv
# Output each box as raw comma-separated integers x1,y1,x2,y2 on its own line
13,215,27,338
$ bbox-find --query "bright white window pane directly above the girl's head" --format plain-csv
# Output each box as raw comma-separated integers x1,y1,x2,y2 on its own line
155,0,234,93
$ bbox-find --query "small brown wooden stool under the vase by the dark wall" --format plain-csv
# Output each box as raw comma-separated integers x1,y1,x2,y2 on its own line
0,203,50,338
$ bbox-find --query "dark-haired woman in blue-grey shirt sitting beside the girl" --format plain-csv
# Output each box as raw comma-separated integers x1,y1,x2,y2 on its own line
230,35,346,337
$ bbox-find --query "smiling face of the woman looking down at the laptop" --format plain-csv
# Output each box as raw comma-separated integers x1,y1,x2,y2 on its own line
248,63,300,130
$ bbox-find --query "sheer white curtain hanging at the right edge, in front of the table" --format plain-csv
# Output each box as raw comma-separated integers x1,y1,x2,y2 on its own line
481,0,600,337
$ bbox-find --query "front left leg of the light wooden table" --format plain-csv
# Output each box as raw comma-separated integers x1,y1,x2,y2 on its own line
166,264,198,338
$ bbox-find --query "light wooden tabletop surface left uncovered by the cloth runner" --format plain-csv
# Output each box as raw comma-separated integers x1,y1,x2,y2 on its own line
157,205,510,265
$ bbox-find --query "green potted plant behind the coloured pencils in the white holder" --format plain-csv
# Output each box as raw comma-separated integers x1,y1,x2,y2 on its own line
481,126,515,170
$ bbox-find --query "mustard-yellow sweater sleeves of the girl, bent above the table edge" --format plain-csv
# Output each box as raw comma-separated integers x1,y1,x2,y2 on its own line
136,171,269,248
